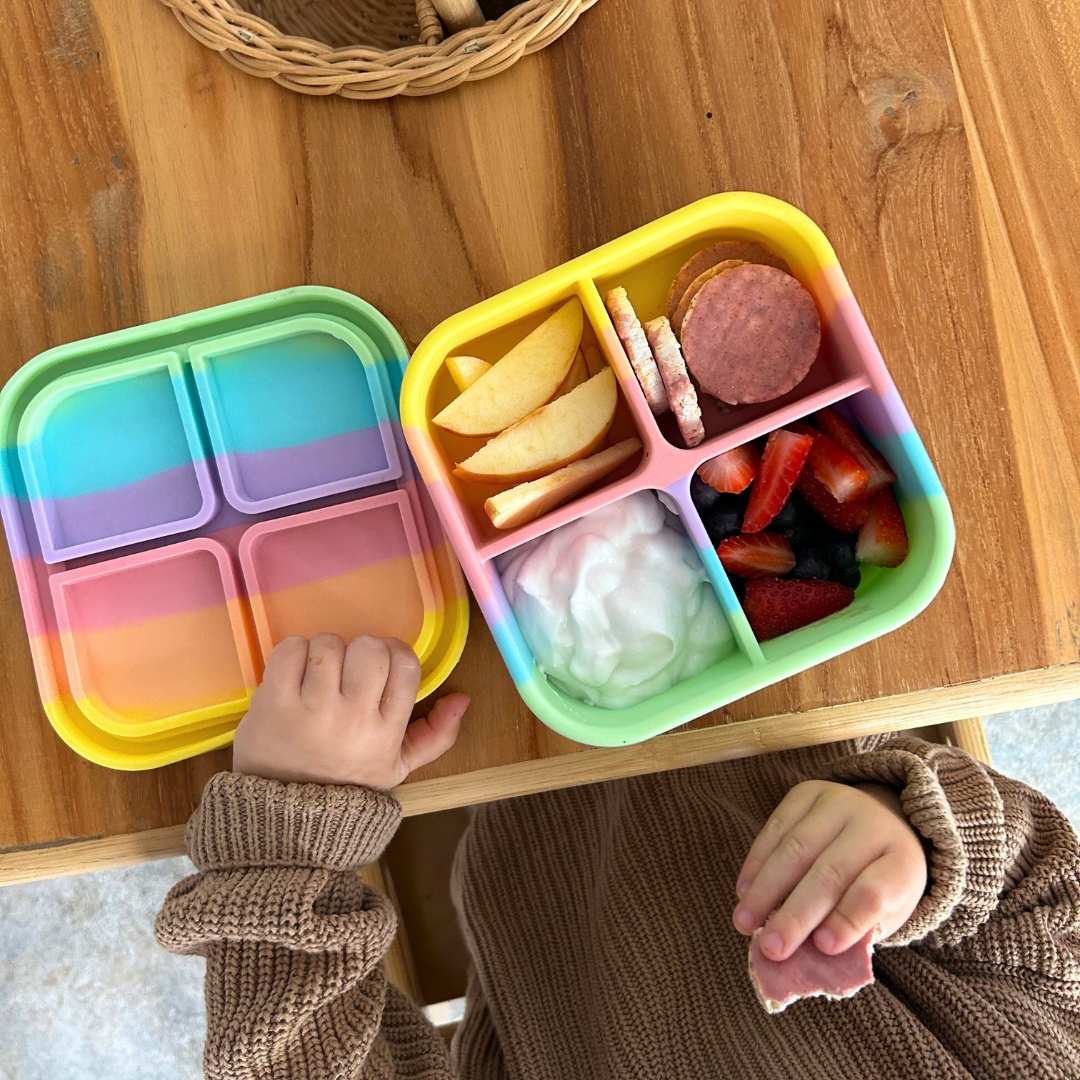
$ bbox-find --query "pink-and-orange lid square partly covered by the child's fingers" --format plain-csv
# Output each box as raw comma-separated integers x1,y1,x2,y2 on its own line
240,491,444,663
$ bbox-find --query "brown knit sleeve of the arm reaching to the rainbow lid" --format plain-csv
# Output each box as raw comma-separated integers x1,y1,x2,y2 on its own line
154,772,450,1080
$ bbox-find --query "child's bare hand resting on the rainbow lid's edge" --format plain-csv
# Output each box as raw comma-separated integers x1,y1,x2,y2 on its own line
232,634,469,791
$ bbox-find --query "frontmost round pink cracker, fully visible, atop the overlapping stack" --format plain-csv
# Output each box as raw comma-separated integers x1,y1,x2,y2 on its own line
683,264,821,405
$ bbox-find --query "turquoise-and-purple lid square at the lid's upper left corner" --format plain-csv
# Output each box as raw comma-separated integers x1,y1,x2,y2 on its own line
18,352,217,563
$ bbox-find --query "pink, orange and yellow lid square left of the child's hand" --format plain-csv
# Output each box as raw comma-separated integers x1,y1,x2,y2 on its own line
50,539,255,737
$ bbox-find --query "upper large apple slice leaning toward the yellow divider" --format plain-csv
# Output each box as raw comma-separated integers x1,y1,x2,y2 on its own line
434,296,584,435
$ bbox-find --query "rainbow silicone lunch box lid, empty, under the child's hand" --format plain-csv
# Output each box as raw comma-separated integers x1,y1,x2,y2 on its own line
0,287,469,769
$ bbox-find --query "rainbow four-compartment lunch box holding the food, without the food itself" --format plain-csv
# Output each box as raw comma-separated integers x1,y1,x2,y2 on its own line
401,192,955,746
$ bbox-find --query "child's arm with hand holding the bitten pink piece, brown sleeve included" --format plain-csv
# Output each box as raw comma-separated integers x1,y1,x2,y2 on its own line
735,737,1080,1077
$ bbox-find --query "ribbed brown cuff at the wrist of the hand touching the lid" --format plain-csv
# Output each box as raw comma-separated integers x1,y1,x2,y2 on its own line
187,772,402,870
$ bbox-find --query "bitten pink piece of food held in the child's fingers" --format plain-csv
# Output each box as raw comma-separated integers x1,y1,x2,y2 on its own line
750,927,875,1013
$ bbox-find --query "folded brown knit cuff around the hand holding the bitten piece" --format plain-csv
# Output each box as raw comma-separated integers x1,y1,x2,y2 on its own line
822,737,1004,945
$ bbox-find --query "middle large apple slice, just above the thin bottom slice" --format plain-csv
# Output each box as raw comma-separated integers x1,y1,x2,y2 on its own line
454,365,619,484
